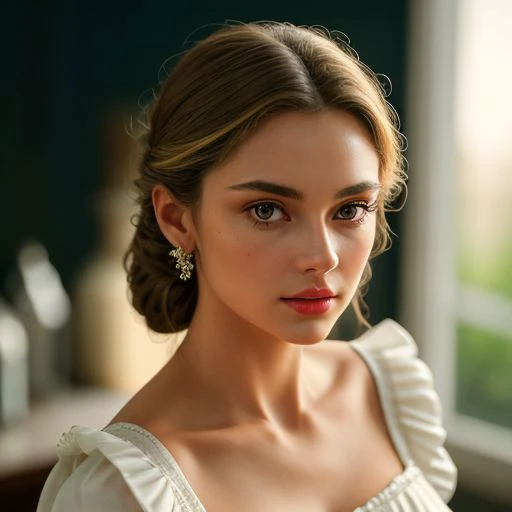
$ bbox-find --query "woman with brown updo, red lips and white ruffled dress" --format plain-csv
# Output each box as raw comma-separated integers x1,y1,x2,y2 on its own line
38,23,456,512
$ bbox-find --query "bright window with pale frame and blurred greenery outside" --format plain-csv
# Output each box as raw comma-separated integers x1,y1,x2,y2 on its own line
401,0,512,499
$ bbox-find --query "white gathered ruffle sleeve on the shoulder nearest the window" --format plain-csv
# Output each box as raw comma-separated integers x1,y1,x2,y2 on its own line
351,319,457,503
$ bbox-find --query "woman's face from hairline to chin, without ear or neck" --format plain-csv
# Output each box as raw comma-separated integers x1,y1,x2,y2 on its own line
192,111,380,344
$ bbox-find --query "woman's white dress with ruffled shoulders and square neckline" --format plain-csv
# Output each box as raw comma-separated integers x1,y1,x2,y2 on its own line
37,320,457,512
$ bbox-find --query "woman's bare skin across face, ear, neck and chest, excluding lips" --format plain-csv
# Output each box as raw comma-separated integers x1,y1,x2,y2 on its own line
113,111,403,512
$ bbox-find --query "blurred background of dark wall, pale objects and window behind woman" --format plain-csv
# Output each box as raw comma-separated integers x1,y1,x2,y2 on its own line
0,0,512,512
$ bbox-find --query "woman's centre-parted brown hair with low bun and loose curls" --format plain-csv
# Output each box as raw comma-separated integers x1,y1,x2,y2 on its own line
125,22,404,333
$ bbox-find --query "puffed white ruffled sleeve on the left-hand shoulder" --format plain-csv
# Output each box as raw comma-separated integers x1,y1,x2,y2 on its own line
37,426,180,512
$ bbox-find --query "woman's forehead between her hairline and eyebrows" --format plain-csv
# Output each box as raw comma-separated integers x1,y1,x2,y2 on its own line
208,111,379,192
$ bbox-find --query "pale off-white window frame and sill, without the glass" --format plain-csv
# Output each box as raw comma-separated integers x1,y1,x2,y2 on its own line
399,0,512,501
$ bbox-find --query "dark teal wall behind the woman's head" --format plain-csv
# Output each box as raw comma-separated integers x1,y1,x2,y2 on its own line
0,0,407,321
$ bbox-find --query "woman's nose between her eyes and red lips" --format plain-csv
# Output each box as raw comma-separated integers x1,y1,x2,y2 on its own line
296,222,339,274
